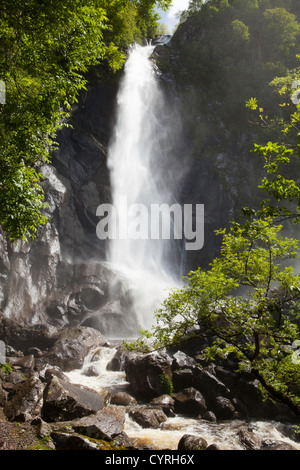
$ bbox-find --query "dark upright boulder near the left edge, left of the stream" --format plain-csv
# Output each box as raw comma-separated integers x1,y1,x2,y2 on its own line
4,375,44,422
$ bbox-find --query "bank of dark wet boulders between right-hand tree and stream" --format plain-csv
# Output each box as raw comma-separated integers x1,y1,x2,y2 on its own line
118,350,298,423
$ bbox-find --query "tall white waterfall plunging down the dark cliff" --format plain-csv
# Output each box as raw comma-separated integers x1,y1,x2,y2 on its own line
108,45,176,328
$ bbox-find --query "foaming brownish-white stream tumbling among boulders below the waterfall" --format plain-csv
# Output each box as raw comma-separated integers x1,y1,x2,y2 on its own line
66,347,300,450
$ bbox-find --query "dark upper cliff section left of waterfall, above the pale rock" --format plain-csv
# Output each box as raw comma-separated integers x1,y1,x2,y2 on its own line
52,83,117,261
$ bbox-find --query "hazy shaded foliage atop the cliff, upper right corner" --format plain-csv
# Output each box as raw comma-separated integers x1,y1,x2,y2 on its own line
174,0,300,127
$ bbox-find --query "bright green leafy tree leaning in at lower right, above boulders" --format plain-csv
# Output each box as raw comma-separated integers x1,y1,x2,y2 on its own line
128,219,300,415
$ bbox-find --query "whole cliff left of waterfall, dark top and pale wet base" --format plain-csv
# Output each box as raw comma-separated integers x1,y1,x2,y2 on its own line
0,78,137,336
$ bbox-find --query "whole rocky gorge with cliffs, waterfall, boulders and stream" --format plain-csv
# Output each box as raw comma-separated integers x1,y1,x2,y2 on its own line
0,3,300,450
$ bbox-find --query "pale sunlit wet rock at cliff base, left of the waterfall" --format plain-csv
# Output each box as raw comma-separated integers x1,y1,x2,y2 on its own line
0,226,137,338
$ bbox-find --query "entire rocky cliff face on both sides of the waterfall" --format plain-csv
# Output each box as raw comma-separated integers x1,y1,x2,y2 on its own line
0,21,268,330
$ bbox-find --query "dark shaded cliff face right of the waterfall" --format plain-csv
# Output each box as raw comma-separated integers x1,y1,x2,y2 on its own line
153,22,263,273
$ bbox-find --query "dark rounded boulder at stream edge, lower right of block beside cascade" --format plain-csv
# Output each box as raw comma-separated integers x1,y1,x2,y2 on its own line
173,387,207,417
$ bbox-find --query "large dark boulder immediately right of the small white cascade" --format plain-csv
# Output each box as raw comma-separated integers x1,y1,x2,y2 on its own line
125,352,172,399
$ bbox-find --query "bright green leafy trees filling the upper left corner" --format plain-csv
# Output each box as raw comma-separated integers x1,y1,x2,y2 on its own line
0,0,171,240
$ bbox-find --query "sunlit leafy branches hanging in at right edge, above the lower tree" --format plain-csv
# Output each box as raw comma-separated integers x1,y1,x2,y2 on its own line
244,63,300,223
